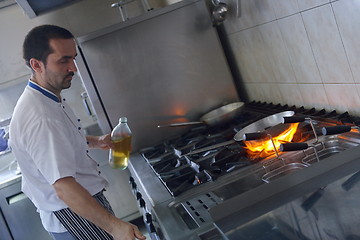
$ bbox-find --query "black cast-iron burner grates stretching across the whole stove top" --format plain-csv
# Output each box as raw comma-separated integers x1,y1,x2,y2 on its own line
140,102,360,196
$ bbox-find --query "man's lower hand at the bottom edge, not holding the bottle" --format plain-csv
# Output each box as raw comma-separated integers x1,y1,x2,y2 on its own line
111,219,146,240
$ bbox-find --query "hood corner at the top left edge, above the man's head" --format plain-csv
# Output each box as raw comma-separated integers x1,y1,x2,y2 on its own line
16,0,79,18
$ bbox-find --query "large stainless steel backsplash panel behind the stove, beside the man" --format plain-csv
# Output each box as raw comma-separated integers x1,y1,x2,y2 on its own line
77,0,238,151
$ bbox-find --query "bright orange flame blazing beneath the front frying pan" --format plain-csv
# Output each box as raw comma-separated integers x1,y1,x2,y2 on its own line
244,123,299,159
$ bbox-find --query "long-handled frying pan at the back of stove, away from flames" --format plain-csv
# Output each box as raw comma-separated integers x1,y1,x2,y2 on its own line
158,102,244,128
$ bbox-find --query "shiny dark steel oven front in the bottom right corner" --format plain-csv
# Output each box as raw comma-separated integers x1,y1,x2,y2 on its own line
212,172,360,240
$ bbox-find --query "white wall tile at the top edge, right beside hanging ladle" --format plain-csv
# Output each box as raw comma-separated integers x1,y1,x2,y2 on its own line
224,0,276,34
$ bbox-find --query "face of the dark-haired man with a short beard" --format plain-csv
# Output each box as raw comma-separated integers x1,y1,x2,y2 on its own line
41,39,77,94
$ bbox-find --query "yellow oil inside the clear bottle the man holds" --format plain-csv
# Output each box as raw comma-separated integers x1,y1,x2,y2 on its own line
110,136,131,170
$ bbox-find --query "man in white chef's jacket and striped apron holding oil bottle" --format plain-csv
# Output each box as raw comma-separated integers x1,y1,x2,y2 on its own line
10,25,145,240
